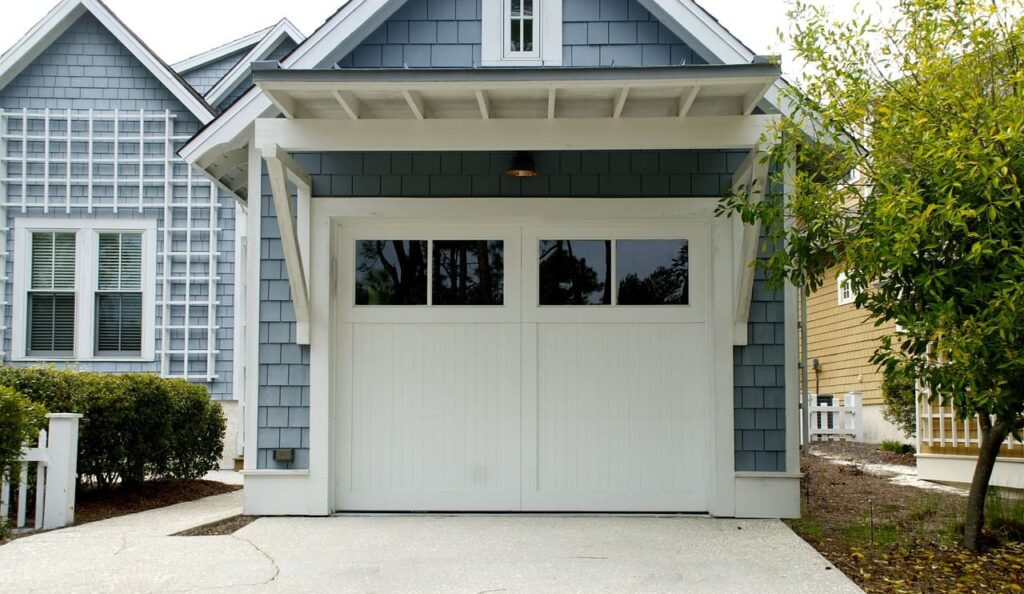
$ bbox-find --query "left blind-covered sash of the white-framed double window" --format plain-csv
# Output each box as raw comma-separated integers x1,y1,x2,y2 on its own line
27,231,77,356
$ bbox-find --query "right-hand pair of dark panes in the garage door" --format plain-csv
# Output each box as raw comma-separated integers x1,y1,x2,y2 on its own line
539,240,690,305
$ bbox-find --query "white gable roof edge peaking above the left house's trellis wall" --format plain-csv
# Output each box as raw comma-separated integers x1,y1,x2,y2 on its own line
0,0,214,124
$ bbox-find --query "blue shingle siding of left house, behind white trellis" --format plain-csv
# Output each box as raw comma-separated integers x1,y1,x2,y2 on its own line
0,13,236,398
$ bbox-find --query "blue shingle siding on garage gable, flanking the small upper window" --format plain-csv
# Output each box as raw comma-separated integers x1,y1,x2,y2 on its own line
338,0,702,68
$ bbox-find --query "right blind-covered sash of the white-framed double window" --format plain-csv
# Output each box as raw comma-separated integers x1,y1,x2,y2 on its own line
95,232,142,355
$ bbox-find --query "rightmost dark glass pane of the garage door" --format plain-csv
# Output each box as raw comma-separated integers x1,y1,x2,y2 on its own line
615,240,690,305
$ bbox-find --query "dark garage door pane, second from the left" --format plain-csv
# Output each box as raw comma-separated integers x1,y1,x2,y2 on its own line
433,241,505,305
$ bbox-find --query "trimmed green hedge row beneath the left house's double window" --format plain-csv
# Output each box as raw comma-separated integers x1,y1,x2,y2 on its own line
0,367,224,486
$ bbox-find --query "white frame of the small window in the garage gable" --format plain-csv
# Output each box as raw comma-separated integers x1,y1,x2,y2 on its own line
480,0,562,67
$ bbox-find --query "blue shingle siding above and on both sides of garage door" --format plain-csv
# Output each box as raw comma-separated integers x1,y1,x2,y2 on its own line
258,151,785,471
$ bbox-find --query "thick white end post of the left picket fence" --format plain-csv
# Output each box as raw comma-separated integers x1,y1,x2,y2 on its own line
43,413,82,529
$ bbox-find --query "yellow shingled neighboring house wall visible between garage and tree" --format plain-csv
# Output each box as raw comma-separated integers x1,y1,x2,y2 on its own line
807,269,897,443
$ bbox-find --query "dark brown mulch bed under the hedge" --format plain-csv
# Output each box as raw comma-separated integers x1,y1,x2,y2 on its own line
0,479,242,545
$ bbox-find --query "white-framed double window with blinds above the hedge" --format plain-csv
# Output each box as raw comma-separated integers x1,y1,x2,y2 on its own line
13,219,156,360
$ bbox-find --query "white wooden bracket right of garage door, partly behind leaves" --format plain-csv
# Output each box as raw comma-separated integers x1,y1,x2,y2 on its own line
732,149,769,346
